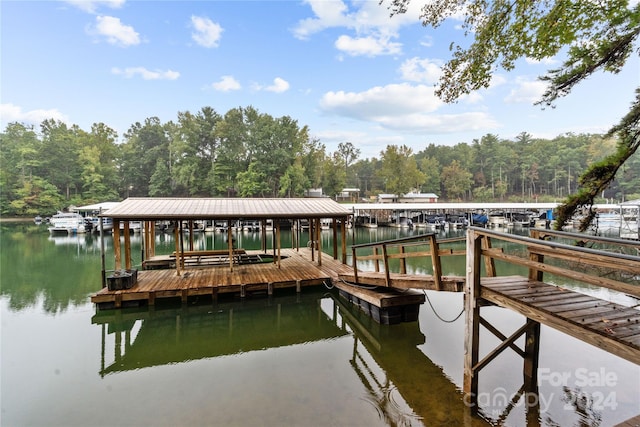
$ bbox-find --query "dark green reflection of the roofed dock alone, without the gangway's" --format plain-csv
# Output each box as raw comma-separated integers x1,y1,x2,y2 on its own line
92,293,347,376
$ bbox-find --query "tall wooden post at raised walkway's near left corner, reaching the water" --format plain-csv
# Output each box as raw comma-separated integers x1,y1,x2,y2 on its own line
463,229,481,414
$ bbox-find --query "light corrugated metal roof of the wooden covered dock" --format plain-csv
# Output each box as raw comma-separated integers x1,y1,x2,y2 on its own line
103,197,351,220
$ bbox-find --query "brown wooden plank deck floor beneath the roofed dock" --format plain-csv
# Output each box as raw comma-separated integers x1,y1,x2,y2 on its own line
91,248,351,308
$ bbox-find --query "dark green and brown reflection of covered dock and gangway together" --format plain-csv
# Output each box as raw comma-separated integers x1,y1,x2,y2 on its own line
92,291,485,426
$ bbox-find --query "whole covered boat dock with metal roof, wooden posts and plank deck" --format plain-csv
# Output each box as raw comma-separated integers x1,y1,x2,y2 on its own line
91,198,352,308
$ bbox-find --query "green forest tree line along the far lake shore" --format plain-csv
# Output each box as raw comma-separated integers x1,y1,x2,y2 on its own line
0,106,640,216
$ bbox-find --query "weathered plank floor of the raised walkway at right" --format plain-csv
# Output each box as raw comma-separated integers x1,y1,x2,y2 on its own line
480,276,640,364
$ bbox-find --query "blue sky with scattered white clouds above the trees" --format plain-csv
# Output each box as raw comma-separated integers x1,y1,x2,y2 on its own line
0,0,640,158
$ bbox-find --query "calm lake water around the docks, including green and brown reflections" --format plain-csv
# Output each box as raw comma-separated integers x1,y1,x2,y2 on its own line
0,223,640,427
